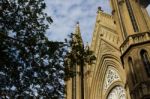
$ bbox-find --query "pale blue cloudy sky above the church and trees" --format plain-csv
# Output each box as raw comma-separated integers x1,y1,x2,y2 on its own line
45,0,150,42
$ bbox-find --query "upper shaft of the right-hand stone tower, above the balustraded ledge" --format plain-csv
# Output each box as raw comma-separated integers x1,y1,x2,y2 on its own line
110,0,150,41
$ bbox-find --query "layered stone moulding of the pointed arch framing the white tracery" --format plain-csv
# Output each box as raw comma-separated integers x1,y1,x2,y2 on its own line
90,54,126,99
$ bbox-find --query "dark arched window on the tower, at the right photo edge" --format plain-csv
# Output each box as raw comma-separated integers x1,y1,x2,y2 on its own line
140,50,150,77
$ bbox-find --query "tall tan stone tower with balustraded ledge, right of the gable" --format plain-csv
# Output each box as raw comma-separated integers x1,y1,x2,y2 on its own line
111,0,150,99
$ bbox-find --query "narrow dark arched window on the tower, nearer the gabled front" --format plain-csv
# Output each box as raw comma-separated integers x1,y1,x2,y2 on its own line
128,57,137,85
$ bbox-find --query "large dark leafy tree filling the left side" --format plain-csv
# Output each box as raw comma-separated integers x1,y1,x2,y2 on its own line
0,0,64,99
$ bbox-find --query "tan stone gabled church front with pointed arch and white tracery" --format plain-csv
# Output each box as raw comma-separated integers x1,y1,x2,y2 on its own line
88,7,130,99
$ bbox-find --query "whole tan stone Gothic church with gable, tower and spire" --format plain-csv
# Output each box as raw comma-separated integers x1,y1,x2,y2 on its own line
65,0,150,99
